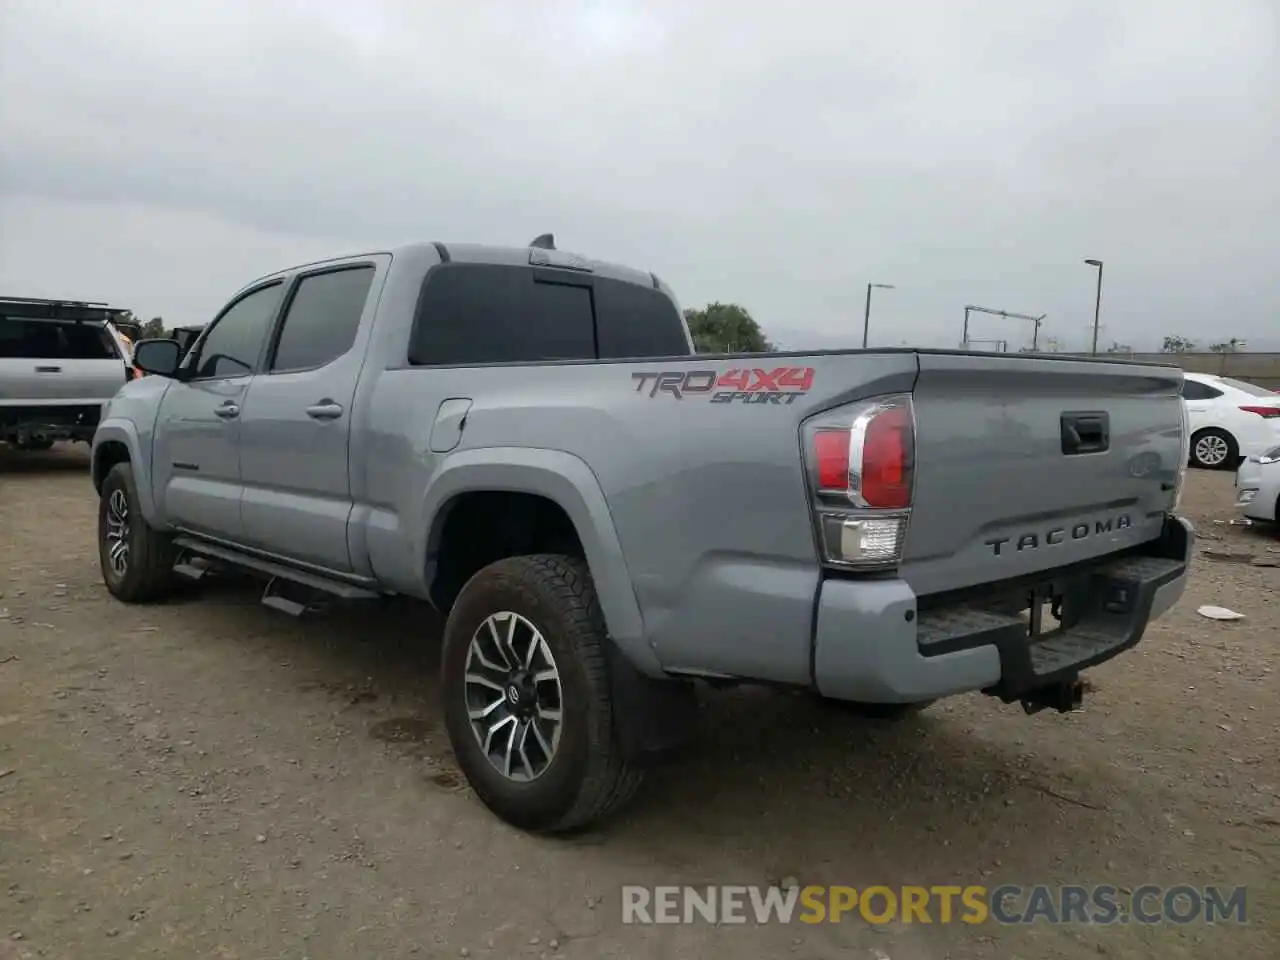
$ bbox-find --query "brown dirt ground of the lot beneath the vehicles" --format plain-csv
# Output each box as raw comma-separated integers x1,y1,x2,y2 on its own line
0,445,1280,960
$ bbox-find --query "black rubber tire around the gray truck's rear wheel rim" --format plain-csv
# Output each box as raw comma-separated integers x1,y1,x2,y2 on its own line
440,554,643,833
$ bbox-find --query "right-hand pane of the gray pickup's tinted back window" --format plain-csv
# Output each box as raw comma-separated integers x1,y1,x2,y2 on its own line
595,278,689,360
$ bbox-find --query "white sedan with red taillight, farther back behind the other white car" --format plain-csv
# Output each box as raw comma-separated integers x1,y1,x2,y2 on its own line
1183,374,1280,470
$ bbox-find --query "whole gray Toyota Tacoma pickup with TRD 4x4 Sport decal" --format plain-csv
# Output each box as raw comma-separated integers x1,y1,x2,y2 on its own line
92,236,1192,831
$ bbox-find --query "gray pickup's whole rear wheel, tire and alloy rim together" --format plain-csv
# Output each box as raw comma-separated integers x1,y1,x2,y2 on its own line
440,554,641,832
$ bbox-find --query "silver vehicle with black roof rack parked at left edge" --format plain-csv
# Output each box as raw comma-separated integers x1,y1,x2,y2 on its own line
0,297,132,449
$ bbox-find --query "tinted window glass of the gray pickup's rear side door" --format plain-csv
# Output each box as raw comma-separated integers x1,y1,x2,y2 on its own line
271,266,374,372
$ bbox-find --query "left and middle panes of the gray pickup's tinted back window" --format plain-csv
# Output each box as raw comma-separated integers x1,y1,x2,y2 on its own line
408,264,595,365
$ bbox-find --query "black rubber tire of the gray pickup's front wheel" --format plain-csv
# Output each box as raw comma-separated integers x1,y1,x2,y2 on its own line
97,463,177,603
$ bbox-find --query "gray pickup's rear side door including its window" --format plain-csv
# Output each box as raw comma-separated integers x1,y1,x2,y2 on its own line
239,256,390,572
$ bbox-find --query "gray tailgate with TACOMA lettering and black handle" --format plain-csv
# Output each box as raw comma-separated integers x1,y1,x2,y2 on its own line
901,352,1185,595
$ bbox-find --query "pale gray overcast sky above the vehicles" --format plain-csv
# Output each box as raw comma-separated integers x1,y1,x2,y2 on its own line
0,0,1280,348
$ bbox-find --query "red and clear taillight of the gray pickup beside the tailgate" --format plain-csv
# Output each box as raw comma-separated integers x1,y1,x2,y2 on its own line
803,394,915,571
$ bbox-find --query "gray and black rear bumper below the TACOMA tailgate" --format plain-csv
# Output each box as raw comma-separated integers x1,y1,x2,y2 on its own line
813,517,1194,703
